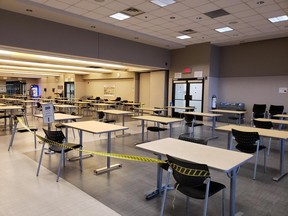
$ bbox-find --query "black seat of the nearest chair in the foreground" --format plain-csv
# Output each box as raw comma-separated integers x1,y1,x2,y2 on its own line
175,181,226,199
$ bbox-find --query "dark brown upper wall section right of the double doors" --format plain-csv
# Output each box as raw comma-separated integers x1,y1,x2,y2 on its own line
219,37,288,77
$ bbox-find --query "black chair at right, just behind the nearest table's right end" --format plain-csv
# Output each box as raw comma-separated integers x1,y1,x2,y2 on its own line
232,129,266,179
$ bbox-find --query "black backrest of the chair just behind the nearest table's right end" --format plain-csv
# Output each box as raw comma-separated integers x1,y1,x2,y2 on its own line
232,129,260,145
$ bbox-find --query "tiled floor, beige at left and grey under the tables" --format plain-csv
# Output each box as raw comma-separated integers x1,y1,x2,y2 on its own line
0,114,288,216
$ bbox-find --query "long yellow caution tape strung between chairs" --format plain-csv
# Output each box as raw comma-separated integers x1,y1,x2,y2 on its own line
17,117,209,177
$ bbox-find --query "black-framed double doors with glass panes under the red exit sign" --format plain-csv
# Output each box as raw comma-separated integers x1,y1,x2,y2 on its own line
172,79,204,117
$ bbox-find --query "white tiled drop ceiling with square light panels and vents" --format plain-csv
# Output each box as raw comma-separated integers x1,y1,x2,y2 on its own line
0,0,288,79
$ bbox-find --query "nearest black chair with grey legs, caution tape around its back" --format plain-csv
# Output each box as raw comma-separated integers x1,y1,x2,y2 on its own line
160,155,226,216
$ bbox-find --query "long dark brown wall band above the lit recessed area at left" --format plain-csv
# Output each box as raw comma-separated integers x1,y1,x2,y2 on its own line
0,9,170,68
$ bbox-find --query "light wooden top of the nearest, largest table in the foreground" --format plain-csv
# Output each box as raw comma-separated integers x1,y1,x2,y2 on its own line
137,138,253,173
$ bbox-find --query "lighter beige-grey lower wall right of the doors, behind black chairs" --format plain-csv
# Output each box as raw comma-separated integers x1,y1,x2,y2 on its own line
218,76,288,121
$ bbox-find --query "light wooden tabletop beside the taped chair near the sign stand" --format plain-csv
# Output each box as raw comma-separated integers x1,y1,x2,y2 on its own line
63,121,128,134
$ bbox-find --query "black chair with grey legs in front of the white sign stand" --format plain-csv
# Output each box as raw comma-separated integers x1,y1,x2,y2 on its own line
36,128,82,182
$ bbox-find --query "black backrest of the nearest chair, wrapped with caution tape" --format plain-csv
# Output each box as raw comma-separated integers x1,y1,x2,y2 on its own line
167,155,210,187
